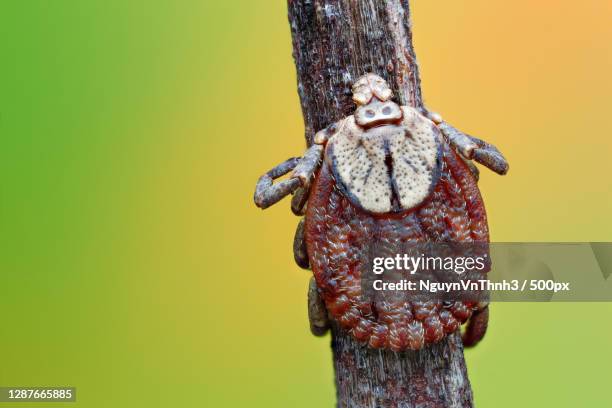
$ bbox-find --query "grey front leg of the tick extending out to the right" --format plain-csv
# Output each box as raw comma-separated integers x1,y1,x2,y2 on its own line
424,110,508,175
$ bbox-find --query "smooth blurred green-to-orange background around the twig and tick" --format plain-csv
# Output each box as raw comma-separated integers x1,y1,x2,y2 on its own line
0,0,612,408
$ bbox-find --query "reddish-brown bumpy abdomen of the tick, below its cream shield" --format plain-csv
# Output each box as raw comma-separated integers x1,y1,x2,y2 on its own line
305,143,489,351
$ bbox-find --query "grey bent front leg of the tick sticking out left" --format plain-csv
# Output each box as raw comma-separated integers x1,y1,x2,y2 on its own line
254,145,323,208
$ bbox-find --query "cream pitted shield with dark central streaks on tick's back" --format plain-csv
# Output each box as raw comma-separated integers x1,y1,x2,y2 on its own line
326,106,441,214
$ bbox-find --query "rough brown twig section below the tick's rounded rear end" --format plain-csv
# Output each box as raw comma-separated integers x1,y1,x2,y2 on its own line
332,324,473,408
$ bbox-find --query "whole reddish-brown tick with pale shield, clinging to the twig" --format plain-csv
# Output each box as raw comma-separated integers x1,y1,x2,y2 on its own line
255,74,508,351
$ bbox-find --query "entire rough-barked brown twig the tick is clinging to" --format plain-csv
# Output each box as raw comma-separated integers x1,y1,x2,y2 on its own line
288,0,473,408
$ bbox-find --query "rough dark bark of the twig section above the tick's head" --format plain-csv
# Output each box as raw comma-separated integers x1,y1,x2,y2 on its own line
288,0,423,145
